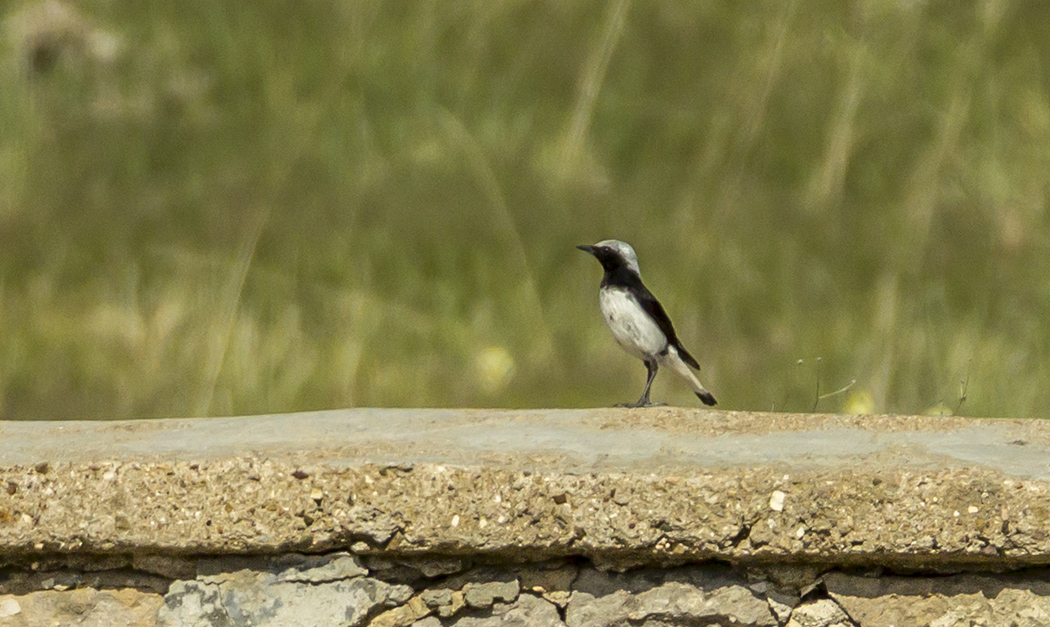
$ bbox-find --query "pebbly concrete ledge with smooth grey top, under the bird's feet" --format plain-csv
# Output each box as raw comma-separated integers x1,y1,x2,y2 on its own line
0,409,1050,571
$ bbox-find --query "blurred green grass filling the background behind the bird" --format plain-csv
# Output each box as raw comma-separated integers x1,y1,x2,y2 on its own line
0,0,1050,419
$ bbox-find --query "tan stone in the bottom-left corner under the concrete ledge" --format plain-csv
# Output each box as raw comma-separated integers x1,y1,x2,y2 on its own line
0,588,162,627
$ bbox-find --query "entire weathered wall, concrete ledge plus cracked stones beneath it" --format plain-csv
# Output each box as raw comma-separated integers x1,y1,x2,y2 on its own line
0,407,1050,627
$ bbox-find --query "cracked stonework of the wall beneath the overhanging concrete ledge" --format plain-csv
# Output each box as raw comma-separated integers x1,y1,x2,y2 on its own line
6,551,1050,627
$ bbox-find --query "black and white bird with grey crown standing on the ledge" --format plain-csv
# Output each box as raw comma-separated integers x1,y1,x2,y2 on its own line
576,239,715,407
